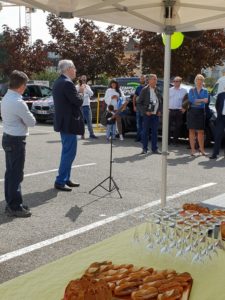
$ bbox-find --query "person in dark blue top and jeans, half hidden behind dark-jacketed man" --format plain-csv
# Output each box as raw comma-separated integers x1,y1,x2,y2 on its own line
133,75,146,142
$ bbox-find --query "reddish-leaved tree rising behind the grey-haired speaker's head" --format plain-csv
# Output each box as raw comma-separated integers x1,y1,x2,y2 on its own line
47,14,135,82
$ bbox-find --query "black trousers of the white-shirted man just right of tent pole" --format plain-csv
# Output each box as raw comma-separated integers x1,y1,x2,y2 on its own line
169,109,183,142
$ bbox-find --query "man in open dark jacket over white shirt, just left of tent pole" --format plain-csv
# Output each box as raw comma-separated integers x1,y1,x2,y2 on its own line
139,74,162,154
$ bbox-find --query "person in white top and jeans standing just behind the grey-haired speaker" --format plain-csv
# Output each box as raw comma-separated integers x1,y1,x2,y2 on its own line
76,75,97,139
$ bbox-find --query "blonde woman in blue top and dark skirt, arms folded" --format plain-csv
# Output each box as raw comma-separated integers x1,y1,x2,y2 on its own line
187,74,208,156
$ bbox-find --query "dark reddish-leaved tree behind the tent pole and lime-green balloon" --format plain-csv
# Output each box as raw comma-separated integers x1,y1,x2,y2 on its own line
135,29,225,80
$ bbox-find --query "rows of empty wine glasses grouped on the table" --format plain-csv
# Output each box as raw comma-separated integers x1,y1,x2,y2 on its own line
133,208,225,263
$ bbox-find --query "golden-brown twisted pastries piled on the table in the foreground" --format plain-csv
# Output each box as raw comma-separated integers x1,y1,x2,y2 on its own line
81,261,193,300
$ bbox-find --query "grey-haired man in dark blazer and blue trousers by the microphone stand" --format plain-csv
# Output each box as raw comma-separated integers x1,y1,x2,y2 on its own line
52,59,84,192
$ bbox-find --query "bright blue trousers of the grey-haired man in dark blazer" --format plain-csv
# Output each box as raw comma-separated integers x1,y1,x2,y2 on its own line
55,132,77,185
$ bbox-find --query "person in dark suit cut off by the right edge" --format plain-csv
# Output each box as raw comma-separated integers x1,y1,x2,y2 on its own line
209,92,225,159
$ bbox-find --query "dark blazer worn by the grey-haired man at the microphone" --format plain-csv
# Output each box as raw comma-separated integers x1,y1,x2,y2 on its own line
52,75,84,135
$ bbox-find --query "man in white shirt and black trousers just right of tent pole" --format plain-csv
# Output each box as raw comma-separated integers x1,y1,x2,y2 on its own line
169,76,187,146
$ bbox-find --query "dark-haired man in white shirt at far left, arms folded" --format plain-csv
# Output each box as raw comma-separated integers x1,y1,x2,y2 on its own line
1,70,36,218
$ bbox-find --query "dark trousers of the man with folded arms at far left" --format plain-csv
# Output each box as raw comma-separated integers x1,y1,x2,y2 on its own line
2,133,26,210
